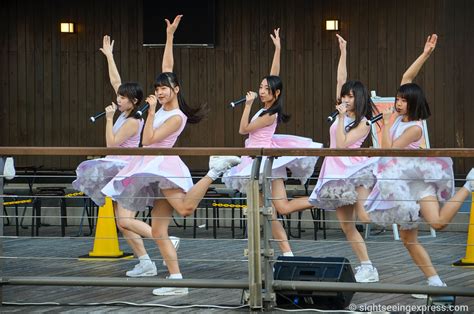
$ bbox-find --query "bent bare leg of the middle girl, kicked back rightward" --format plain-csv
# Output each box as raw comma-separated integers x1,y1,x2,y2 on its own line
272,179,313,215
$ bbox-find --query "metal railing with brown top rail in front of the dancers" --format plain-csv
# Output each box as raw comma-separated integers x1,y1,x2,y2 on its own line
0,147,474,310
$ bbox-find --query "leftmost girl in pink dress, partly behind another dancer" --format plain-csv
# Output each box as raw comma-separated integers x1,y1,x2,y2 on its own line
72,35,157,277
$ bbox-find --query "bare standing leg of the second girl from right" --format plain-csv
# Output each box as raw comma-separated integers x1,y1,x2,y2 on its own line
336,205,369,262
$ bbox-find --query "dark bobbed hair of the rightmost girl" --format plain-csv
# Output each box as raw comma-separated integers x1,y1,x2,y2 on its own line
397,83,431,121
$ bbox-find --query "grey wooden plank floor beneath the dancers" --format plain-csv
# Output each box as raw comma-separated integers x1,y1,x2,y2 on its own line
0,226,474,313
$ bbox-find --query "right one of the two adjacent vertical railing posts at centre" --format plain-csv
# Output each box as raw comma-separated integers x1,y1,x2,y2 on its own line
262,157,276,310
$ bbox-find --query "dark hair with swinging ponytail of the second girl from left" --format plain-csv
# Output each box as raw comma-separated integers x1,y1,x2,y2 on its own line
154,72,209,123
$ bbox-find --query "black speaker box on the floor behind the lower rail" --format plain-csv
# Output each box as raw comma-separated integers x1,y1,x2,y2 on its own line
274,256,355,310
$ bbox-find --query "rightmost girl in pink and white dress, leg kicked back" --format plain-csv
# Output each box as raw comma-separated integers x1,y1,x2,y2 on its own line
365,34,474,298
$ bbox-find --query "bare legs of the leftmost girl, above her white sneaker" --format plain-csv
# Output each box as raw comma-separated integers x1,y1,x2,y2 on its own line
114,202,151,257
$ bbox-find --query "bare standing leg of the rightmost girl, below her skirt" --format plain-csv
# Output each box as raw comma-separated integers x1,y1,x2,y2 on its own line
400,229,437,278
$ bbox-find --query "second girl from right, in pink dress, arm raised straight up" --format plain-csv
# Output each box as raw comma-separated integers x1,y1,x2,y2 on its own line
309,35,379,282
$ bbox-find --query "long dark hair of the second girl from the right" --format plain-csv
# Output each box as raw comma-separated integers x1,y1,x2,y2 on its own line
339,81,377,132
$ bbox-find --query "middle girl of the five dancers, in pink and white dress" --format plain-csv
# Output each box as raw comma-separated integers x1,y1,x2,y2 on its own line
222,29,322,256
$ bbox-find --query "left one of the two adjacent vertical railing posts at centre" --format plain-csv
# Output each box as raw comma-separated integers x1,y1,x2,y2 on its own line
247,156,263,309
